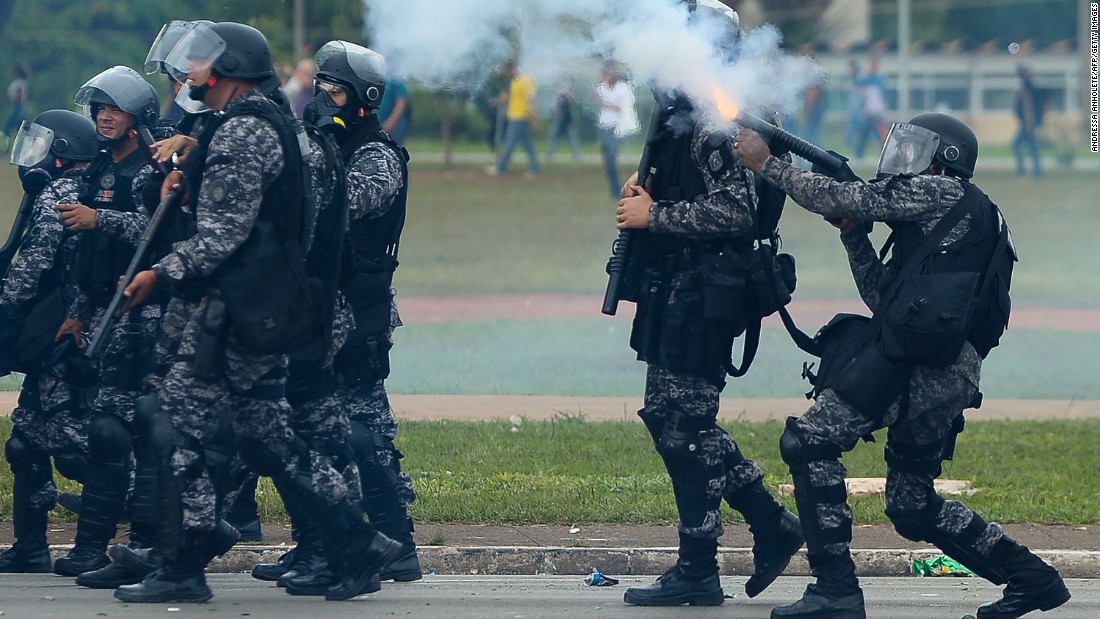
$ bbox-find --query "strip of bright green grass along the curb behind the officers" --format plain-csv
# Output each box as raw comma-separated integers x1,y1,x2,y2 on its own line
0,416,1100,524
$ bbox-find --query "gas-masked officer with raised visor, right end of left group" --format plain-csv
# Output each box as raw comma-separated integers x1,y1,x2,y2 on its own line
253,41,422,593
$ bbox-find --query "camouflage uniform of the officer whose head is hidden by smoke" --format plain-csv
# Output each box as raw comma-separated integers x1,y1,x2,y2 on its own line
628,117,798,576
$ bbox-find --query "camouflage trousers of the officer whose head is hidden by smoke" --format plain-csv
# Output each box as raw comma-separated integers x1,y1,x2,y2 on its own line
638,364,763,540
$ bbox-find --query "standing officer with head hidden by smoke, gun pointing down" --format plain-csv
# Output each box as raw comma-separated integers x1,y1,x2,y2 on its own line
617,1,802,606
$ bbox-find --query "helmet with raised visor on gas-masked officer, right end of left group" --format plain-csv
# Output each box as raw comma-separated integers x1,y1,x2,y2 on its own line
314,41,386,110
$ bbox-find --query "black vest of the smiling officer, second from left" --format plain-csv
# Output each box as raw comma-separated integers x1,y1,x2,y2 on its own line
74,150,145,307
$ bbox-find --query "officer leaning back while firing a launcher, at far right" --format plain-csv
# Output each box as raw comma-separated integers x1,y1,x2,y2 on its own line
735,113,1069,619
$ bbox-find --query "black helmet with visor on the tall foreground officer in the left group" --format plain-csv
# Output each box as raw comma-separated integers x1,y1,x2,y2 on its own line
160,21,275,86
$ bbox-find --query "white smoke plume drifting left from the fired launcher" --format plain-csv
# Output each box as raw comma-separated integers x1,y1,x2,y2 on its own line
364,0,823,121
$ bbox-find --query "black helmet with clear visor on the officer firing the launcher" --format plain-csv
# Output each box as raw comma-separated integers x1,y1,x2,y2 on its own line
878,112,978,178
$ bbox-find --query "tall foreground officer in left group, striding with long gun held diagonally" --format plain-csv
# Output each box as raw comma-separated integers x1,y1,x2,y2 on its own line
116,22,404,603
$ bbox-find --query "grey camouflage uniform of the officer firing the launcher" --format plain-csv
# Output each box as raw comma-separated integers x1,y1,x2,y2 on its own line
763,157,1003,573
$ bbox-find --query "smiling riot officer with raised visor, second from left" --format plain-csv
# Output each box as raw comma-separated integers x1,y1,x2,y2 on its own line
54,66,161,587
